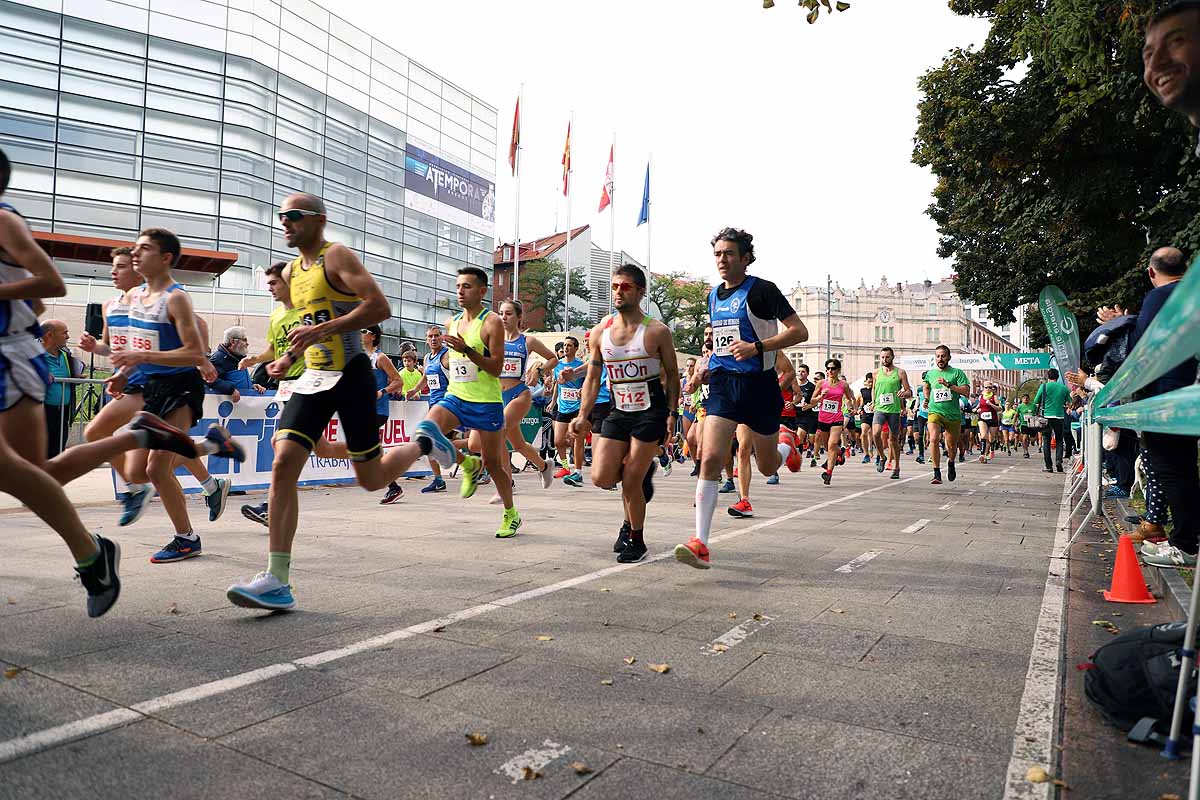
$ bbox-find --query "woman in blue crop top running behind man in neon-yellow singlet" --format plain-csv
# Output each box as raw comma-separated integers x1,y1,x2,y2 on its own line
490,300,558,505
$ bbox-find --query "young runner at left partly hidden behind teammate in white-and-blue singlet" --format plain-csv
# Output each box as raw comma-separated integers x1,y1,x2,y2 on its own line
79,247,230,522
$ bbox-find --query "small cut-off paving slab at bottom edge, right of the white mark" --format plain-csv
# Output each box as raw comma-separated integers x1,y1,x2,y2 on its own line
571,758,780,800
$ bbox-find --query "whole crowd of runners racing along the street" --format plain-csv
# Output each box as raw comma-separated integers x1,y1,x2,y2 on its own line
0,148,1061,616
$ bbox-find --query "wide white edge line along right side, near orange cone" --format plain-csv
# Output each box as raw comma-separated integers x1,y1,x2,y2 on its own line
1003,480,1070,800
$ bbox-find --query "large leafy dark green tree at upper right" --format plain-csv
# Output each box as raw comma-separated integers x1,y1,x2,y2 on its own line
913,0,1200,347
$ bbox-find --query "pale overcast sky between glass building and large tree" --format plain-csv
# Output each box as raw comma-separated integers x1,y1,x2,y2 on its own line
337,0,986,290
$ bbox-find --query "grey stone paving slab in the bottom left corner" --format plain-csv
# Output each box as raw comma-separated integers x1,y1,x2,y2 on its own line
0,720,344,800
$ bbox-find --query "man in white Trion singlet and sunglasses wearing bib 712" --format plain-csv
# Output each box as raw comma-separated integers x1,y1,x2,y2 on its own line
571,264,679,564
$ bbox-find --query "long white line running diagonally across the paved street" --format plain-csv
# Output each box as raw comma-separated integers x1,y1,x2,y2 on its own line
0,473,930,764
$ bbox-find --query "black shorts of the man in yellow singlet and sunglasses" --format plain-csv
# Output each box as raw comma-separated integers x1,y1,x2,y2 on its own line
275,353,382,462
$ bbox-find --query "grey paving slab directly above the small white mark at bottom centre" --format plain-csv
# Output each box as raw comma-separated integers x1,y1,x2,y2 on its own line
430,658,767,771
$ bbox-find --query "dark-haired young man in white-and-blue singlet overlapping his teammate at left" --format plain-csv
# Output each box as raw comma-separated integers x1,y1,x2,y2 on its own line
108,228,244,564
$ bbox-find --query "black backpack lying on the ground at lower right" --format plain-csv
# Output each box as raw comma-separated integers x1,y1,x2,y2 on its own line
1084,622,1196,733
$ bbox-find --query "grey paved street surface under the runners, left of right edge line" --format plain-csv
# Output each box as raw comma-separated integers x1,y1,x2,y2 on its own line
0,456,1063,800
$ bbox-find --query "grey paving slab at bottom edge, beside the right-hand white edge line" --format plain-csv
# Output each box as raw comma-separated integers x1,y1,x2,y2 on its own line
707,711,1008,800
